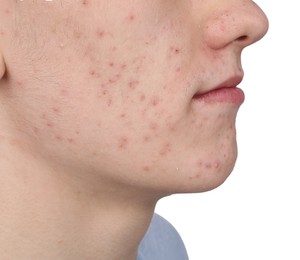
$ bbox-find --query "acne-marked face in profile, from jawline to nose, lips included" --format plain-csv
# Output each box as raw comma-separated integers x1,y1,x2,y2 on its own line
4,0,267,195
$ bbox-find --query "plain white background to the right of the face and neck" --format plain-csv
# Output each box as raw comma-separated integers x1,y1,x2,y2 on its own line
156,0,300,260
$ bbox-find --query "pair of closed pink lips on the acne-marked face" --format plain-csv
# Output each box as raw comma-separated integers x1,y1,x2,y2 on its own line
193,76,245,105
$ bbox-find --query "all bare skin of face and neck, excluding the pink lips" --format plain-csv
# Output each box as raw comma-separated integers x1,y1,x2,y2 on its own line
0,0,268,260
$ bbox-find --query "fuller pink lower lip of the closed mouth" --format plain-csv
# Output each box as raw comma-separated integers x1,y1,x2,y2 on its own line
193,87,245,105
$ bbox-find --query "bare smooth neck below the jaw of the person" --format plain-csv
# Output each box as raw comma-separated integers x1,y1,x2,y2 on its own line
0,137,157,260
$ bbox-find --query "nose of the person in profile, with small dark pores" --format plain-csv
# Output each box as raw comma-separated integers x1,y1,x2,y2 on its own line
201,0,268,49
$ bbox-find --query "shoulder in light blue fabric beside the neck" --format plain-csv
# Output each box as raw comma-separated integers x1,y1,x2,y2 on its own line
137,214,188,260
